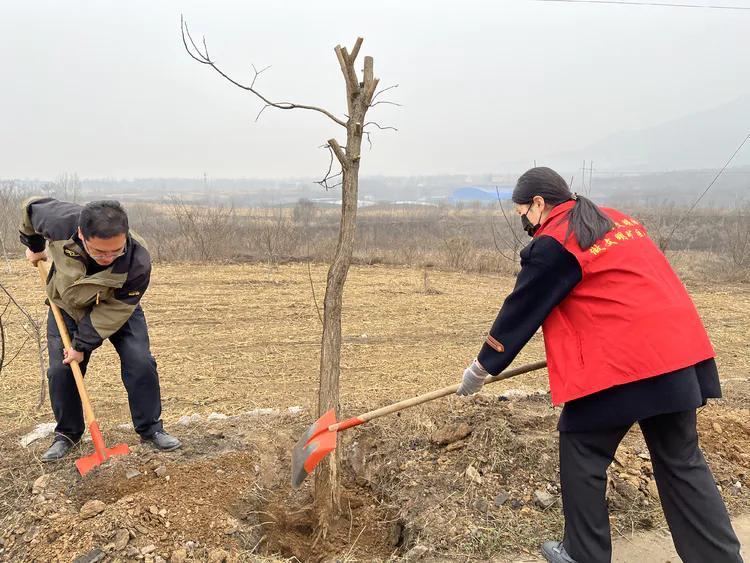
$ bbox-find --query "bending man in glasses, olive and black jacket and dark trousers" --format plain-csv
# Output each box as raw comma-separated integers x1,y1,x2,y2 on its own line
20,197,181,461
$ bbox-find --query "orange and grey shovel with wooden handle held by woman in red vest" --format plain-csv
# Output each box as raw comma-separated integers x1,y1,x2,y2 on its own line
292,361,547,489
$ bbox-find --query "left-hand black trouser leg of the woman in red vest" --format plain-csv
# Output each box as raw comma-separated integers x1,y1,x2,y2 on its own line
560,426,630,563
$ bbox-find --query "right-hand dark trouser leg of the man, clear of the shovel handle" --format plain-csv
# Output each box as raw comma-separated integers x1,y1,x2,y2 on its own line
109,306,163,437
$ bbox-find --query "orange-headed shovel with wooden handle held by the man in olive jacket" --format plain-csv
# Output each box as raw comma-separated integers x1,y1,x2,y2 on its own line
37,262,130,477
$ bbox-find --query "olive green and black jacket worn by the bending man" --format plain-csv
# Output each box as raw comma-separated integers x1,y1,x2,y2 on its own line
20,197,151,352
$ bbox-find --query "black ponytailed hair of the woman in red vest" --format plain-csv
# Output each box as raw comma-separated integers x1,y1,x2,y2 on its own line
512,166,615,250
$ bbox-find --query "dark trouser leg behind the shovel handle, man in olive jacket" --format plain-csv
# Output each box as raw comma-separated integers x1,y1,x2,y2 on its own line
47,309,90,442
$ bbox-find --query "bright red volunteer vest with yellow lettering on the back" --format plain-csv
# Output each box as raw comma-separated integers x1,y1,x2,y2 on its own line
535,201,715,405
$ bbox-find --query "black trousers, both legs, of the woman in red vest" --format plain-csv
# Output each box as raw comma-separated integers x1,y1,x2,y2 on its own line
560,410,742,563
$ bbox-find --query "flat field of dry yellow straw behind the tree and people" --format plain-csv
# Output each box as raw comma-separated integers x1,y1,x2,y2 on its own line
0,261,750,432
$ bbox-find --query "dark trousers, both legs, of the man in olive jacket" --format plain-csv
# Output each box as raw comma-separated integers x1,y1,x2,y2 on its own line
47,306,162,442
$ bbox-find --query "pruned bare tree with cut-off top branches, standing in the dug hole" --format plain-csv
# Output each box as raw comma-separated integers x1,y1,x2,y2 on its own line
181,15,397,536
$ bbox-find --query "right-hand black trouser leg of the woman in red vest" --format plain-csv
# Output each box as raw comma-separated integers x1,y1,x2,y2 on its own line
639,410,742,563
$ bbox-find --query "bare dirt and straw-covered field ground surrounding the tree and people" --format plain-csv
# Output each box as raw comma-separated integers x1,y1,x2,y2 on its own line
0,262,750,561
